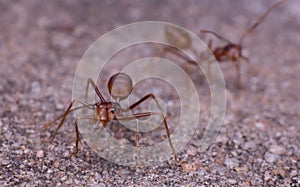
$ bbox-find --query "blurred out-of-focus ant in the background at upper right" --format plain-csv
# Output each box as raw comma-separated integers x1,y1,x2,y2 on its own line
160,0,286,88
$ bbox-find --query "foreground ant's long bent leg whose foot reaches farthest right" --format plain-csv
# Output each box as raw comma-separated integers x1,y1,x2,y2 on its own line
117,112,178,163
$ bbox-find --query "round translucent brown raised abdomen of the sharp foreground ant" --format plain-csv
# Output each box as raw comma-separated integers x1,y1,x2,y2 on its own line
108,73,133,100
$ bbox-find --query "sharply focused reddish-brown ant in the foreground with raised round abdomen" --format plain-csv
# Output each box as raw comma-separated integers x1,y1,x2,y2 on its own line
41,73,178,162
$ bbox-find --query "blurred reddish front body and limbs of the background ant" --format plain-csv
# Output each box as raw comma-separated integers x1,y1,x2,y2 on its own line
200,0,286,88
